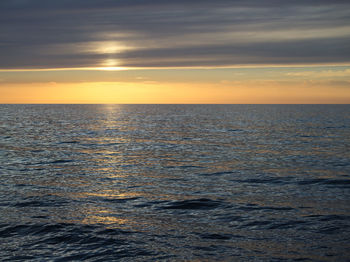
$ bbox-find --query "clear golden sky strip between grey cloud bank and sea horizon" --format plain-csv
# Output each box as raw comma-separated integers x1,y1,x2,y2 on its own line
0,67,350,104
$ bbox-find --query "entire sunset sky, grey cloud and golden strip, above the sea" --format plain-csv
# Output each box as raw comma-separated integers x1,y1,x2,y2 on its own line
0,0,350,104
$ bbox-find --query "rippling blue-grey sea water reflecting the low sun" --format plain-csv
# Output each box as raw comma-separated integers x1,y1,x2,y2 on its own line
0,105,350,261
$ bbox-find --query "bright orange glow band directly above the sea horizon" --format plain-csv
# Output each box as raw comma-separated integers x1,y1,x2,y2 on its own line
0,81,350,104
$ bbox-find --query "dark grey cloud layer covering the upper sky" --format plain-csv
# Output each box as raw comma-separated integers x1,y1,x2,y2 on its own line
0,0,350,69
